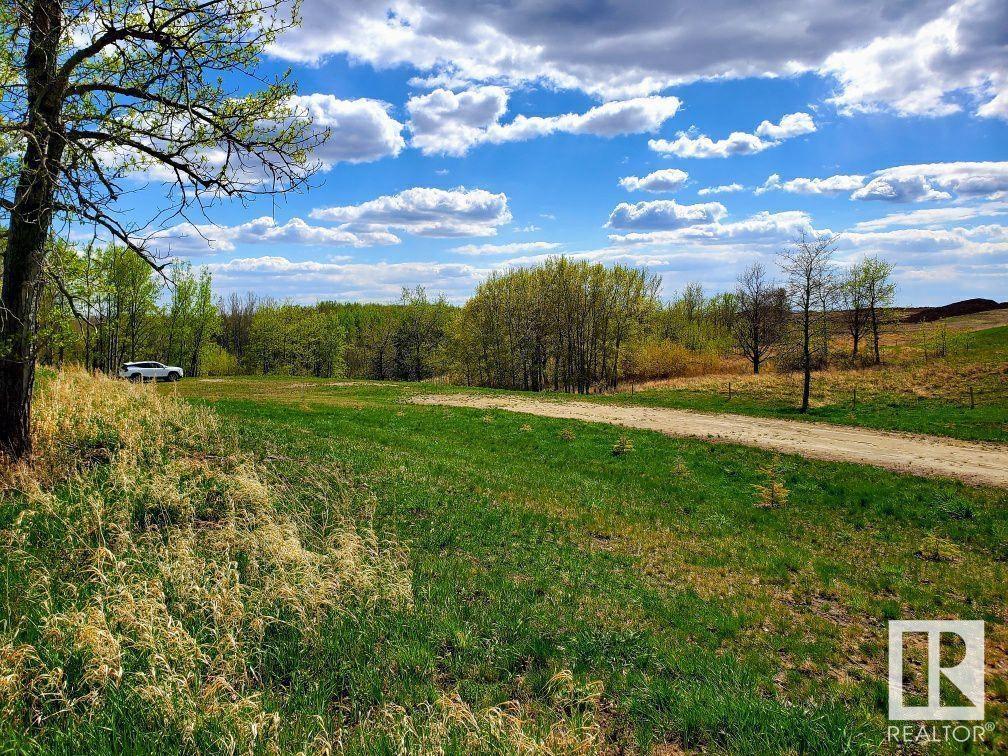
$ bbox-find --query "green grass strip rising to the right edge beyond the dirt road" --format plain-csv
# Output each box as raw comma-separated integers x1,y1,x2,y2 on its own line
592,327,1008,442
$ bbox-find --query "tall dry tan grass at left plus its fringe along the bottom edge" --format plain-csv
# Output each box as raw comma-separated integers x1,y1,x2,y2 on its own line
0,371,602,754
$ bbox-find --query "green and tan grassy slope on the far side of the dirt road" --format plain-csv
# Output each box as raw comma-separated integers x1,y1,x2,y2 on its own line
597,320,1008,442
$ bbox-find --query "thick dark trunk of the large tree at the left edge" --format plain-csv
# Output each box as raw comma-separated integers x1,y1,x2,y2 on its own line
0,0,65,459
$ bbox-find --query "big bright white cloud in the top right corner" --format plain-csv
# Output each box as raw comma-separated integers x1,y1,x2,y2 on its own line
822,0,1008,118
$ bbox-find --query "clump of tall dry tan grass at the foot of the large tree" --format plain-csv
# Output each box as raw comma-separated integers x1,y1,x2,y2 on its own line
0,371,411,751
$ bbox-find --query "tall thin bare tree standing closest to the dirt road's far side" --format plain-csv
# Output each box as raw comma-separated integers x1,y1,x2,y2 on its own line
780,231,837,412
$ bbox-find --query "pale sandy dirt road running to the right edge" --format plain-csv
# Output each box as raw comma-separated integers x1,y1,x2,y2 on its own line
413,394,1008,488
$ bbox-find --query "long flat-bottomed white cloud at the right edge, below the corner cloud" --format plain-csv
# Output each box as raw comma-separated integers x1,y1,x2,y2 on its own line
851,162,1008,203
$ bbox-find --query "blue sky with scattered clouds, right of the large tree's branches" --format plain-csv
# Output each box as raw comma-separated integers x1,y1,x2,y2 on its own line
138,0,1008,304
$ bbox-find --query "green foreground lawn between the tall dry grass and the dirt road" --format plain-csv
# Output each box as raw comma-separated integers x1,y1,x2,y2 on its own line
155,379,1008,753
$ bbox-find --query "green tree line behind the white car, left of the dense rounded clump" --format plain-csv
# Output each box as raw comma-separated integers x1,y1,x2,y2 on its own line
36,248,458,381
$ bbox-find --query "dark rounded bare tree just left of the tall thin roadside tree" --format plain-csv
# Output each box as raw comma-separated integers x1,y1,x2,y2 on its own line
732,262,788,375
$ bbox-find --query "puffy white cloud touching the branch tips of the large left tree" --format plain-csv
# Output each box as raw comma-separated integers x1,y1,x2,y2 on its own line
292,94,405,168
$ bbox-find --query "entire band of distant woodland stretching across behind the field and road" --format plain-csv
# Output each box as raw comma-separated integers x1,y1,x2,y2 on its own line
38,236,892,393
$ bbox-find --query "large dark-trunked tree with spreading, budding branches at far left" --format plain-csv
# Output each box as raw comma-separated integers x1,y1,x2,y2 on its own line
0,0,326,458
